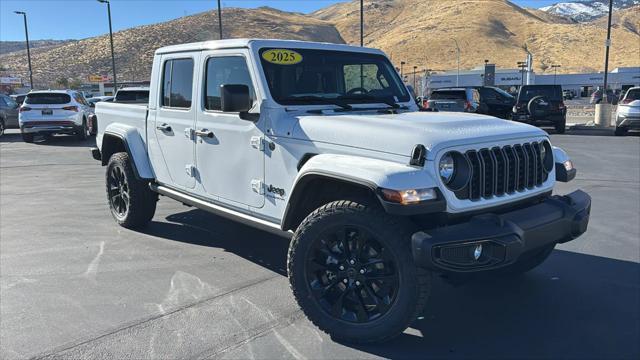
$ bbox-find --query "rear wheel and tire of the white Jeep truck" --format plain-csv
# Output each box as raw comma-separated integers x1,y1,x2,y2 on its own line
105,152,158,229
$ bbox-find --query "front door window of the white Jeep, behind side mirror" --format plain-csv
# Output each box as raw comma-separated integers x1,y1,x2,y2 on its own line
204,56,256,110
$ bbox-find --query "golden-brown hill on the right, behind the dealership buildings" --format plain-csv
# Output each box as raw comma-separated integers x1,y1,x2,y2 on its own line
311,0,640,72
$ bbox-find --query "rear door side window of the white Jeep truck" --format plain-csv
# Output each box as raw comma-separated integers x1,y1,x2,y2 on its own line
162,59,193,109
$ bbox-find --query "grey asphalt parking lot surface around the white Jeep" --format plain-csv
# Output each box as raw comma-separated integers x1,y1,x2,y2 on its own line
0,131,640,359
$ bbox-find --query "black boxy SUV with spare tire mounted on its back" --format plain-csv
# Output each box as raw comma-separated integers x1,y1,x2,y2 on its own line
512,85,567,134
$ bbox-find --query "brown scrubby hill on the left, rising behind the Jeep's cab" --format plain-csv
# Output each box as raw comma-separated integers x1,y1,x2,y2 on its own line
0,7,344,87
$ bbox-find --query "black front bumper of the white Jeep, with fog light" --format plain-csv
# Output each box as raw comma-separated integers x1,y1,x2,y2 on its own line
411,190,591,272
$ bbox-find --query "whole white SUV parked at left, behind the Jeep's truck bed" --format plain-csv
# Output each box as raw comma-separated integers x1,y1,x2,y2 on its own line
18,90,93,142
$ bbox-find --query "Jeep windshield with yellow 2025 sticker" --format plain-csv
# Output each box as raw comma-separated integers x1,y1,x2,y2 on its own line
260,49,410,105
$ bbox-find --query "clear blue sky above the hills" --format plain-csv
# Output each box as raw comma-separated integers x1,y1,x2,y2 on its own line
0,0,558,41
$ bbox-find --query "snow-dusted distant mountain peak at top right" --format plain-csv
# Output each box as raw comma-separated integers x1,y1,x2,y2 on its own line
540,0,640,22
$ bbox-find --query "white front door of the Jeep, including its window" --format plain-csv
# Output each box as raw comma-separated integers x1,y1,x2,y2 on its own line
196,50,264,208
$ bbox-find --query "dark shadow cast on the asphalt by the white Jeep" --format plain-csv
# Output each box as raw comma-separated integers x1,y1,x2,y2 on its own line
144,210,640,359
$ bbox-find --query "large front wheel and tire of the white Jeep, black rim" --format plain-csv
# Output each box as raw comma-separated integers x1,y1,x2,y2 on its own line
287,200,431,344
